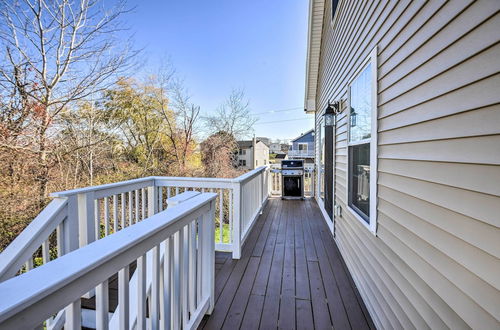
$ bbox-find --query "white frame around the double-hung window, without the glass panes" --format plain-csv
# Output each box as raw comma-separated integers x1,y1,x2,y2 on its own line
346,47,378,235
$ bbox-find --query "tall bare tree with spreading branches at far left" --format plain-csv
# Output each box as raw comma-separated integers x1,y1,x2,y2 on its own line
0,0,136,204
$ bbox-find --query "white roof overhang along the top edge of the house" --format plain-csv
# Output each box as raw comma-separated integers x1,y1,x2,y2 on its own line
304,0,325,113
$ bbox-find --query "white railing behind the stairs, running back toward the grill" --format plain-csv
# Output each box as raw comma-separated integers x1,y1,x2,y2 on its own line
0,166,269,281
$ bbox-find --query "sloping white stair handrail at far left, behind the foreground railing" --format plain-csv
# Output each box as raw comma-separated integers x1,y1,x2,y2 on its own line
0,198,67,281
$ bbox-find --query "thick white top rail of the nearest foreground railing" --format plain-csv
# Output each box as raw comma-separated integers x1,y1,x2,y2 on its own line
0,193,217,327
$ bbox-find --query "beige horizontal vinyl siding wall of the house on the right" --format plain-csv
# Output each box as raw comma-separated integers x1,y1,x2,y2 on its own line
315,0,500,329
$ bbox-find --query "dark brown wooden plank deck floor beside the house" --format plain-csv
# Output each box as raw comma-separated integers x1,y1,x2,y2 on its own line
200,199,374,329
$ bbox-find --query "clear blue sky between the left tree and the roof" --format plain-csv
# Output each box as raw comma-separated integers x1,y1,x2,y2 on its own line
124,0,314,139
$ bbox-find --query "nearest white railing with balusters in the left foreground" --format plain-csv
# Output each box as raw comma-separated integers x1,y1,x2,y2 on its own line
0,193,217,329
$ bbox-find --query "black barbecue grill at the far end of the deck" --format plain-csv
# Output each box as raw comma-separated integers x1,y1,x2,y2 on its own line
281,159,304,199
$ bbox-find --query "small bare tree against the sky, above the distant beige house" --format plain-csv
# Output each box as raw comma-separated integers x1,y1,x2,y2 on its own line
205,89,257,139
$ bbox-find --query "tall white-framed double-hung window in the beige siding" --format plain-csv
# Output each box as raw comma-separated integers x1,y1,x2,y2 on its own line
347,49,377,232
